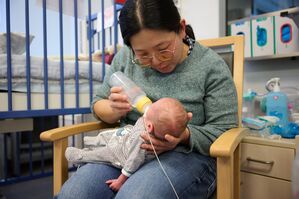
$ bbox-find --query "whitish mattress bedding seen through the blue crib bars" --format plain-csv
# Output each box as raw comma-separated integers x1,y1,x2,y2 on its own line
0,54,109,93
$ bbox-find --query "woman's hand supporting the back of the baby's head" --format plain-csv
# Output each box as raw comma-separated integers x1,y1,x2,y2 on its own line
141,128,190,154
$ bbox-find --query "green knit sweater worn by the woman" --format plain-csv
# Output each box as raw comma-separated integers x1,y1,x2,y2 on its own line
92,42,238,155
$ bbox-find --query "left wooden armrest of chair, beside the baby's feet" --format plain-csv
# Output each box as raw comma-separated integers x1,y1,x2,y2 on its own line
40,121,119,142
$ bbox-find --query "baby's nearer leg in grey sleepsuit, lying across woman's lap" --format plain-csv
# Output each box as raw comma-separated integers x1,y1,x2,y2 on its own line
65,147,112,164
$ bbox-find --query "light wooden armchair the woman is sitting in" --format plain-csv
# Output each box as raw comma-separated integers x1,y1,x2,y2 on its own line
40,36,247,199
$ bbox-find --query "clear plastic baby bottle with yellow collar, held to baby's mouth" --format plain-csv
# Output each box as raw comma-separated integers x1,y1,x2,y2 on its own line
109,71,152,113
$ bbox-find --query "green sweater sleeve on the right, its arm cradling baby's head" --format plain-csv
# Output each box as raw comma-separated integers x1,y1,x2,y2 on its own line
179,52,238,155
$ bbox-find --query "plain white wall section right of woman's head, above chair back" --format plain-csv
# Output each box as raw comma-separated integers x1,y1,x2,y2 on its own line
181,0,226,39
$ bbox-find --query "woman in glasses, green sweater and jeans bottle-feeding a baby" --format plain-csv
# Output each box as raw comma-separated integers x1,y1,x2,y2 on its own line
59,0,237,199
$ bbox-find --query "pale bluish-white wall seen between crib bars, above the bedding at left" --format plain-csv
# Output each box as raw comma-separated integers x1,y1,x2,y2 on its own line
0,0,83,56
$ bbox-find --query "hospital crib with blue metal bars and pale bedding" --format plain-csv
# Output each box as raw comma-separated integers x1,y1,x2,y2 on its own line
0,0,122,186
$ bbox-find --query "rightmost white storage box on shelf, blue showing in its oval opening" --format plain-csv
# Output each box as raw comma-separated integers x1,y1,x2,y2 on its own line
274,16,299,54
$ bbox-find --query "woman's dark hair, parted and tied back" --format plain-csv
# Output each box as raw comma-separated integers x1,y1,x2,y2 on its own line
119,0,195,47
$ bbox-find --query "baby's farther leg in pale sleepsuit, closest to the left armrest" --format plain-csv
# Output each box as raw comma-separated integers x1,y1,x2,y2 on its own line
83,129,117,147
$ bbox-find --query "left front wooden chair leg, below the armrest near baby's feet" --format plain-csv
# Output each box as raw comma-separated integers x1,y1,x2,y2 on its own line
53,138,68,196
